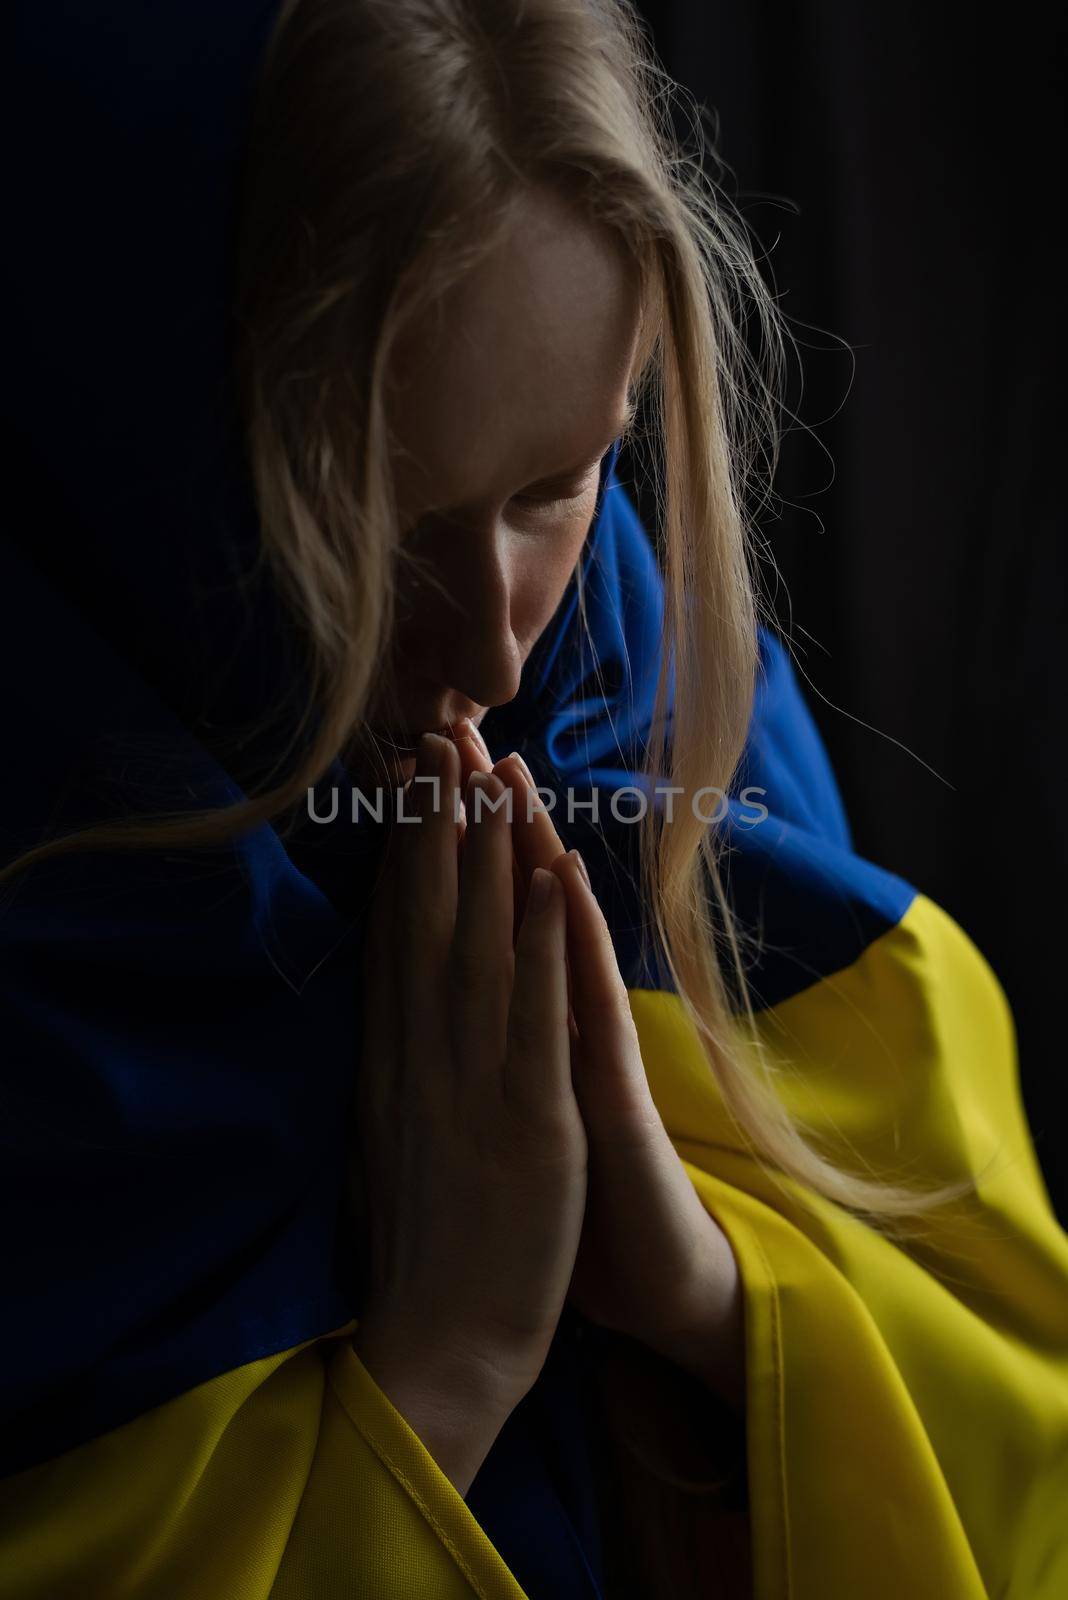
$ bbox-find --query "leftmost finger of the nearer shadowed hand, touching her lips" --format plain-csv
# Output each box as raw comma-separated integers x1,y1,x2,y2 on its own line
390,733,459,1106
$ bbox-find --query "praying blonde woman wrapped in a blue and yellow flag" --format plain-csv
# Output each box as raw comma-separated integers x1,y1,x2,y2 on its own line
0,0,1068,1600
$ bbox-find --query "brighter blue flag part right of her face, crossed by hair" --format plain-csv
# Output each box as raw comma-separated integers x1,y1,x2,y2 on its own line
483,467,916,1008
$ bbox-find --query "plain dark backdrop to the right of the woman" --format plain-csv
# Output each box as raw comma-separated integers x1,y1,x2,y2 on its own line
620,0,1068,1224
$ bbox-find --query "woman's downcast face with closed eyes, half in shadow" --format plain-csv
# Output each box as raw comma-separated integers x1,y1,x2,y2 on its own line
357,189,638,781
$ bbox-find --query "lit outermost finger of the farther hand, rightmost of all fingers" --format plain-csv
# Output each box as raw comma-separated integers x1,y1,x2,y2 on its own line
553,850,662,1141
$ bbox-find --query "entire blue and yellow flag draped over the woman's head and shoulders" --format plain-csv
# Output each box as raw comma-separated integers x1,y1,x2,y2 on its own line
0,0,1068,1600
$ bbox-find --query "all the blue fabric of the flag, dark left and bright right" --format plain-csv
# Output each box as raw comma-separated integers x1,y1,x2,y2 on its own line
0,0,913,1600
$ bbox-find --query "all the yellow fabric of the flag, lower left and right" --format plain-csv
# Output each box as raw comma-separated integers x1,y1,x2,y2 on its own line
0,896,1068,1600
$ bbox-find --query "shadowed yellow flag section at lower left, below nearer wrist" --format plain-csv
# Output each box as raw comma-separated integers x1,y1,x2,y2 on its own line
0,1322,526,1600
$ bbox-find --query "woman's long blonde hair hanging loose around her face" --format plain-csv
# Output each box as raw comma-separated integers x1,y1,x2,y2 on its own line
0,0,970,1226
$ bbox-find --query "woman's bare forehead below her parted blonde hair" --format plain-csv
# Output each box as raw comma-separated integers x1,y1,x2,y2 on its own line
387,192,638,506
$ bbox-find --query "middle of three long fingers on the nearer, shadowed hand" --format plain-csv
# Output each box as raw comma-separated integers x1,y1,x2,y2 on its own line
449,771,515,1096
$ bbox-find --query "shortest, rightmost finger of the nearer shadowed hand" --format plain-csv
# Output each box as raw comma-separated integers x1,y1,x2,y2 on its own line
504,869,574,1123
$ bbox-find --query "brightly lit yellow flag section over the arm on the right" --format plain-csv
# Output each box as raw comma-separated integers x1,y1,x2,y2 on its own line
632,896,1068,1600
